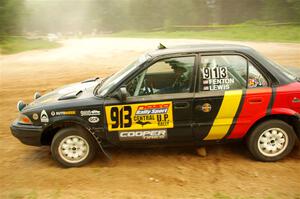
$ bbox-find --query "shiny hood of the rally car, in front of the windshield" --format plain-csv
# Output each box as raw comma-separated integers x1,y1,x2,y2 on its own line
24,78,102,110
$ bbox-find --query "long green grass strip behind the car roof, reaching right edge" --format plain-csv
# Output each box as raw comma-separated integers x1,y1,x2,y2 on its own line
109,25,300,43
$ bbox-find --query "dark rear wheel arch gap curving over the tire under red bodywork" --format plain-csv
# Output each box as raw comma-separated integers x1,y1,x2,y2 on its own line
245,114,300,139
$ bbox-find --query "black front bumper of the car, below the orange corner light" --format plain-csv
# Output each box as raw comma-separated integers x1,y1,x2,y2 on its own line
10,122,43,146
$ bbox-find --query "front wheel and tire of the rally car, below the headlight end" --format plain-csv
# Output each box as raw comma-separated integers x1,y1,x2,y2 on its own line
51,127,96,167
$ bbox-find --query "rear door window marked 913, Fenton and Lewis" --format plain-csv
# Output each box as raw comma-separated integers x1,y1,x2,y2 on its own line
200,55,248,91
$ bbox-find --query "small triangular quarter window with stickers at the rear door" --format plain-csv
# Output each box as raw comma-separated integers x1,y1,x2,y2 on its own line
248,62,268,88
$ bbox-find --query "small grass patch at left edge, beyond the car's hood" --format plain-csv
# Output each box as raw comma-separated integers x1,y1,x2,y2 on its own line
0,37,60,54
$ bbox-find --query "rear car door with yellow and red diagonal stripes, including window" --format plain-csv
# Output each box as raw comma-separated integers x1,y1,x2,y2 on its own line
193,53,271,141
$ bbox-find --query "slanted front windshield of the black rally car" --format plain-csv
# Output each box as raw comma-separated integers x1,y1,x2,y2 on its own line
95,54,150,96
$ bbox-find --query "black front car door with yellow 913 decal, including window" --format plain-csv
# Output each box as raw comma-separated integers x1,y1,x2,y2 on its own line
105,55,197,145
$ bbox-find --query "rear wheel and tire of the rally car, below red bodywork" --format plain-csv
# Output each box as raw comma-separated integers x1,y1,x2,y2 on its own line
247,119,296,162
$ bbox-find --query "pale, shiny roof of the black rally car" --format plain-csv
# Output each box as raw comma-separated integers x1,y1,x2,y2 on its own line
148,44,255,57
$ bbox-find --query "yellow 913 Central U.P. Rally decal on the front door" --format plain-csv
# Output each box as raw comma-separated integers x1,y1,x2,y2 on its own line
105,101,173,131
